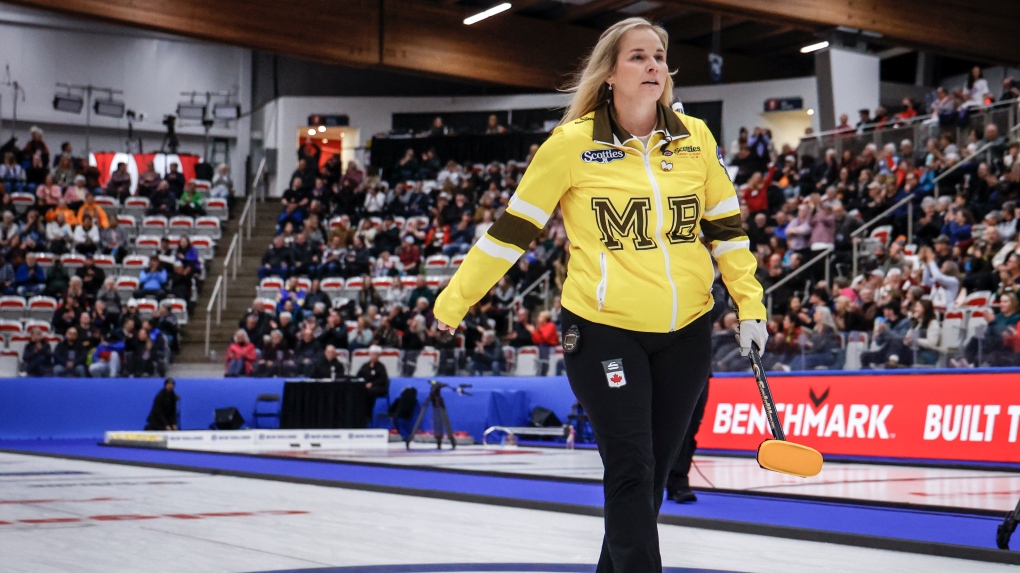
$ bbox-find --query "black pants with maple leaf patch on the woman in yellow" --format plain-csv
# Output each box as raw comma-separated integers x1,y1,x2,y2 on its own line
561,309,712,573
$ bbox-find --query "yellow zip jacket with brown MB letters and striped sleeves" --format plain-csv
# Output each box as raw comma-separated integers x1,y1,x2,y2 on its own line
435,104,766,332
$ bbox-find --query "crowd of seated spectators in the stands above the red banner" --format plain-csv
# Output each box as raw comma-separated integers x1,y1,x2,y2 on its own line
715,68,1020,370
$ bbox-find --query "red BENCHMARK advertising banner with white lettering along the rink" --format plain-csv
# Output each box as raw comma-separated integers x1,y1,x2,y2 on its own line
698,372,1020,462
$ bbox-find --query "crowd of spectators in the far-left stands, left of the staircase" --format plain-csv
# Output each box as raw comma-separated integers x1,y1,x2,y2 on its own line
0,127,217,377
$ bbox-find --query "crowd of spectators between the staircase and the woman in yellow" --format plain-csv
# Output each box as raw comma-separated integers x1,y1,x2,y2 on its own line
232,128,566,375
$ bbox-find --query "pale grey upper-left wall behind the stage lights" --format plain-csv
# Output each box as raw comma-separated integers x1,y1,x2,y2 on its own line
0,4,252,177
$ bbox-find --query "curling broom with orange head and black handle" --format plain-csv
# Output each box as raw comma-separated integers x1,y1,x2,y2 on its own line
750,344,823,477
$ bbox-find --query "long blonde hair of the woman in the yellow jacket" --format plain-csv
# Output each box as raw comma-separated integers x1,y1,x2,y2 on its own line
560,17,673,125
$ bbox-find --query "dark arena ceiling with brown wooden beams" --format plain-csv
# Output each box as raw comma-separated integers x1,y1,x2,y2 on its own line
10,0,1020,90
